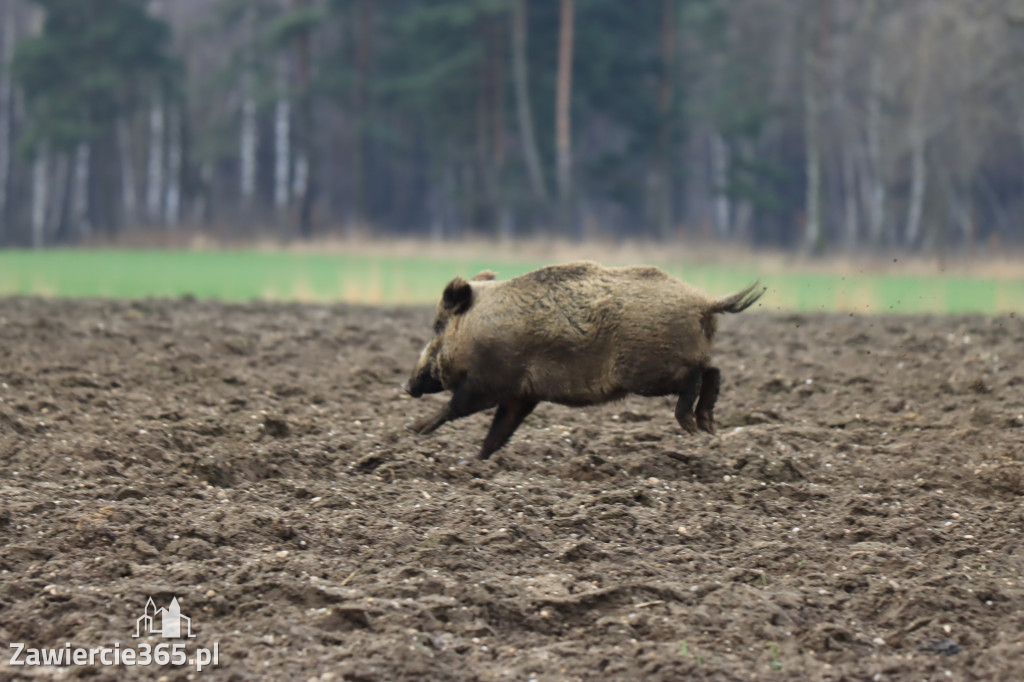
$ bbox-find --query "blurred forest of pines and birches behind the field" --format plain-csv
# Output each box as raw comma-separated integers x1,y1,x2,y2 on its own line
0,0,1024,253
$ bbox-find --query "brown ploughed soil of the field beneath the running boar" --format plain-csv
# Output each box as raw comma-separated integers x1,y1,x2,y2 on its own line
0,299,1024,680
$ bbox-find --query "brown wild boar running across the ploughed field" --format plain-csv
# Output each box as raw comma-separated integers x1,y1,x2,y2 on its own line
404,262,764,459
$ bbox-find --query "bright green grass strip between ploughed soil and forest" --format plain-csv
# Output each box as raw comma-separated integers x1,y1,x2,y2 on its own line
0,250,1024,314
